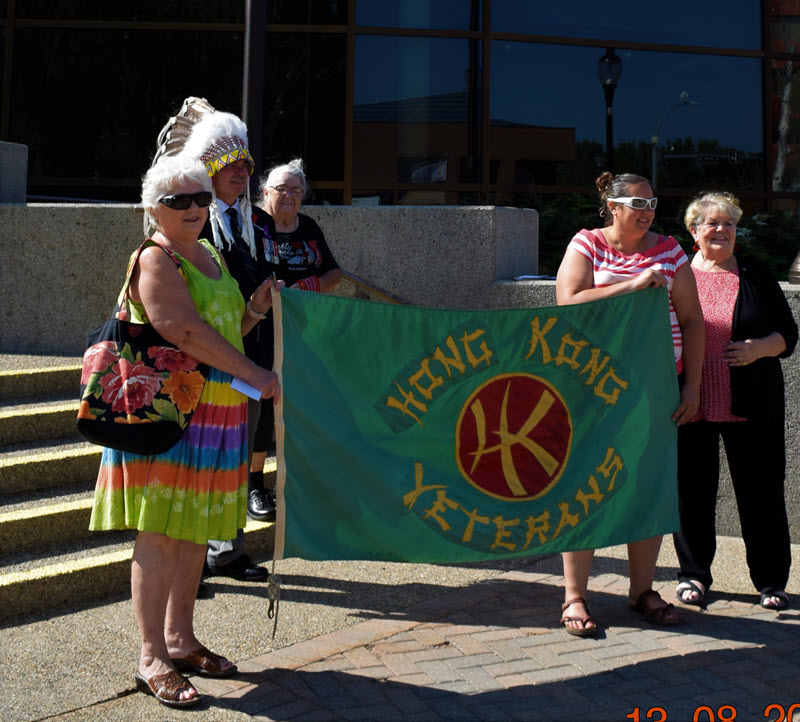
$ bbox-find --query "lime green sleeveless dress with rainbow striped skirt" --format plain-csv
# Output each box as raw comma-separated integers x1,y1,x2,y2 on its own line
89,240,247,545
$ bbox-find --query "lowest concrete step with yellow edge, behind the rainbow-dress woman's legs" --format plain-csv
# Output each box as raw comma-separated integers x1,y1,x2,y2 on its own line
0,520,275,624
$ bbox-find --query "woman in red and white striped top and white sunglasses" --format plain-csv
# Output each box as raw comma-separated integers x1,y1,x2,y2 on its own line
556,172,705,637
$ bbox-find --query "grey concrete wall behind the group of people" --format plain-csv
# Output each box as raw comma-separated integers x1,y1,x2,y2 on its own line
0,204,800,540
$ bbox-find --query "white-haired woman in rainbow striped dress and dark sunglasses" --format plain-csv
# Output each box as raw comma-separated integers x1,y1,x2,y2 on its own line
90,156,278,707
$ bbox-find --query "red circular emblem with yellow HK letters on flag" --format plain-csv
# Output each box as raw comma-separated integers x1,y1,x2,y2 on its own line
456,373,572,501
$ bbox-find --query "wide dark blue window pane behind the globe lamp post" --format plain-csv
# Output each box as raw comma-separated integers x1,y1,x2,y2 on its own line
490,41,764,190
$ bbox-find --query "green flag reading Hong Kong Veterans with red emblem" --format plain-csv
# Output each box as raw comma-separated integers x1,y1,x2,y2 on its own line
275,289,679,562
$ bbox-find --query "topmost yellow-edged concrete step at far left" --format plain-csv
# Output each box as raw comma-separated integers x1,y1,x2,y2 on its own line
0,354,81,404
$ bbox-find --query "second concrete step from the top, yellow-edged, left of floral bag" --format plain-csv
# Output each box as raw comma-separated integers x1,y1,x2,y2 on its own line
0,393,78,446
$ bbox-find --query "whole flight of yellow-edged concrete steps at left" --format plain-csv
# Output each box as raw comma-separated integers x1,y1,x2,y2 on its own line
0,354,276,624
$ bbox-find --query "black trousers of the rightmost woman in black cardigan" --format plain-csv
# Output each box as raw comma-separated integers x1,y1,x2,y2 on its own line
673,419,791,591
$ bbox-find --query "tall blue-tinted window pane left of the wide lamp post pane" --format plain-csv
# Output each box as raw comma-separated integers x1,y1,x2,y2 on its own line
353,35,480,204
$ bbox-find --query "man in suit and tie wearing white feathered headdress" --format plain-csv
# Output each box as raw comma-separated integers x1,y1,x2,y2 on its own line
170,99,275,584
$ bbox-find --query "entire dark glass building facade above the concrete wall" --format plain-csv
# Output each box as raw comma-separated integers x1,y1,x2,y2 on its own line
0,0,800,270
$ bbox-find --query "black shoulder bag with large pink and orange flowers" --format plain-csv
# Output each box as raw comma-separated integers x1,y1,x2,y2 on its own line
77,239,208,455
